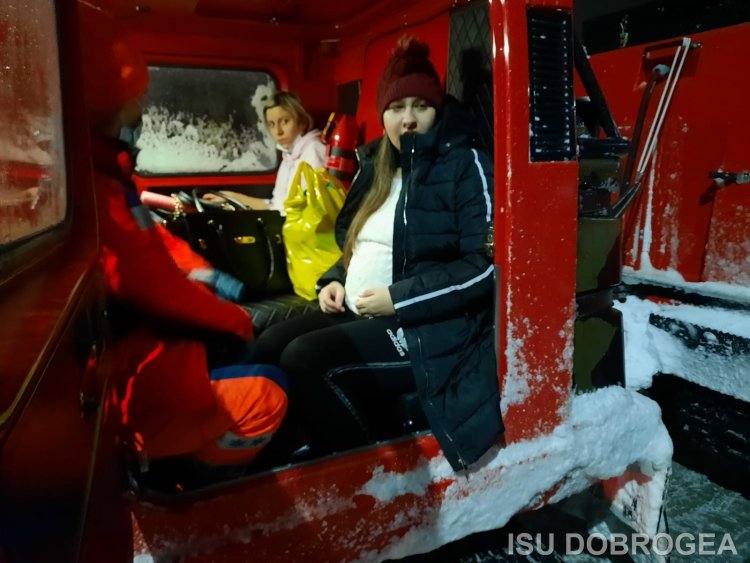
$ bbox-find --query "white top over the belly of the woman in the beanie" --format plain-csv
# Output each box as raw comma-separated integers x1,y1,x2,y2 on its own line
344,177,401,313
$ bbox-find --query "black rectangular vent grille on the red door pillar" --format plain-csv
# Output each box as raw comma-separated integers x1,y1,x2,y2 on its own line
527,9,576,161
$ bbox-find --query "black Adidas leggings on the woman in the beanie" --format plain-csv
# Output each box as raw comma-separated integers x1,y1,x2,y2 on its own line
254,311,415,451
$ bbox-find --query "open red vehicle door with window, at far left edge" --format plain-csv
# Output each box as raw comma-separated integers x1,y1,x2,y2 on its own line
0,0,130,562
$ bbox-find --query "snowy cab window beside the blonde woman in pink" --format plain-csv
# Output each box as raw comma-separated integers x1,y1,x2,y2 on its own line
136,66,277,175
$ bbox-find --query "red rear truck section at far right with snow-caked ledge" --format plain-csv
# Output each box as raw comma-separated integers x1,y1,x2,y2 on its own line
584,1,750,496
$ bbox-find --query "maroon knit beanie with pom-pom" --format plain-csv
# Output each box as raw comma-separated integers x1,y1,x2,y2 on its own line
375,37,443,119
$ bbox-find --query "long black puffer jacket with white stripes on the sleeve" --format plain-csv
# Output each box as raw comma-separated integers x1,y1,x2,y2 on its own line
319,103,503,470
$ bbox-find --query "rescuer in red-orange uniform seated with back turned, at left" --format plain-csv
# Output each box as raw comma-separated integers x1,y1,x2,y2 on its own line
79,1,287,474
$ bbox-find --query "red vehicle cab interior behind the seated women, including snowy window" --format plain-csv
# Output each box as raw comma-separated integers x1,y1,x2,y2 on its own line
98,2,506,494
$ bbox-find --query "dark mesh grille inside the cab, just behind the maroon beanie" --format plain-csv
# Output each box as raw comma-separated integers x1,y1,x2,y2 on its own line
445,2,494,154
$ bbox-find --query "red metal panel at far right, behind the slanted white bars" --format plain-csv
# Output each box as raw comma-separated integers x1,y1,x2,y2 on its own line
592,24,750,283
